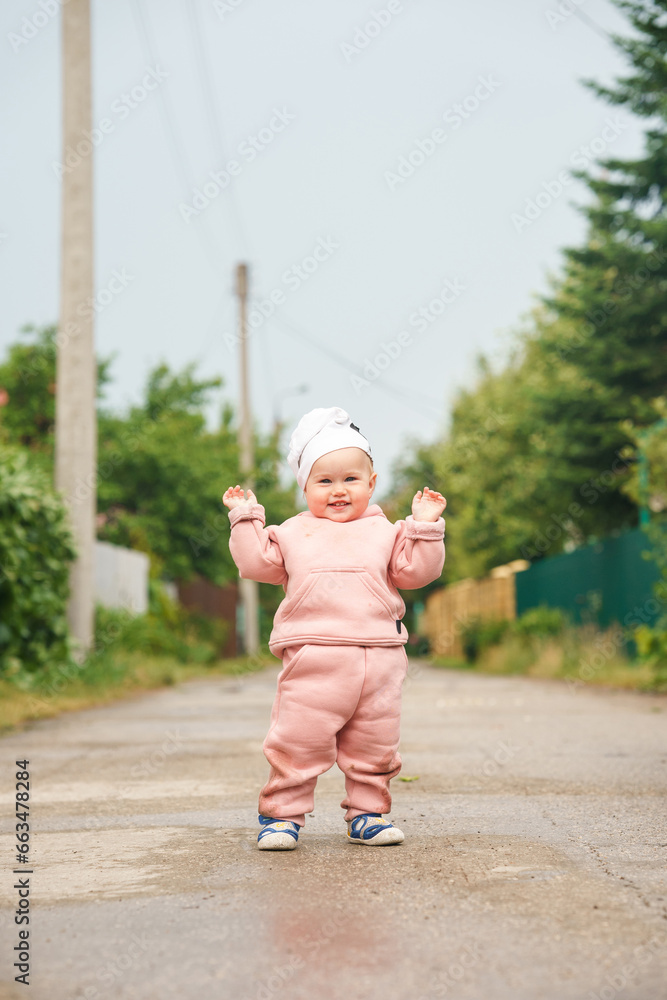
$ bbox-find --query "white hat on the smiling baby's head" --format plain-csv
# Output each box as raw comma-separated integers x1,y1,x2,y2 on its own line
287,406,372,490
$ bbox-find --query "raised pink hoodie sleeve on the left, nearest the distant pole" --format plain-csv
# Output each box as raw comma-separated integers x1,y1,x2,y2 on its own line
229,503,287,584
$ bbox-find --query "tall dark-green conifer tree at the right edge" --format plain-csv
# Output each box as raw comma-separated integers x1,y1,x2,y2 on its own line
529,0,667,533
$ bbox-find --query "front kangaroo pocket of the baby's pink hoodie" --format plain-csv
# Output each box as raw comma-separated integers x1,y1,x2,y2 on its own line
279,566,400,623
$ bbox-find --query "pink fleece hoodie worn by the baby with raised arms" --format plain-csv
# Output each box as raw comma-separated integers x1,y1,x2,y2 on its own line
229,504,445,656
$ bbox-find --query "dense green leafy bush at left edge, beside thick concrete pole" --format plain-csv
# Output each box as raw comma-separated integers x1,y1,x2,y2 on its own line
0,449,76,675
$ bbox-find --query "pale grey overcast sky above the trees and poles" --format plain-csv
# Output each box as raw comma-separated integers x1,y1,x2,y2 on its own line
0,0,642,500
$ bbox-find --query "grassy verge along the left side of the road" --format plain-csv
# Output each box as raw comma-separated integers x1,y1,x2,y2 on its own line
0,649,278,732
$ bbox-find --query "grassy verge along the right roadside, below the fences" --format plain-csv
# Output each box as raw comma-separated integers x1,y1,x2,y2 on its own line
431,627,665,691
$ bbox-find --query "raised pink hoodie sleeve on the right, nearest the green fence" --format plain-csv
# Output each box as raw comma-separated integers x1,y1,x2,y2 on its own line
389,514,445,590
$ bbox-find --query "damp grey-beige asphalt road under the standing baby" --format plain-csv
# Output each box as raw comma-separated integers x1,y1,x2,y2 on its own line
0,661,667,1000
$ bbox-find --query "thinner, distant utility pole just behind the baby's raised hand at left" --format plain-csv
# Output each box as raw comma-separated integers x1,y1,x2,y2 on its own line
236,264,259,656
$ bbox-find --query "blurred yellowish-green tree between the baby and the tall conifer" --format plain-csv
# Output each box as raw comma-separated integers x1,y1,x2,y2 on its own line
391,347,583,582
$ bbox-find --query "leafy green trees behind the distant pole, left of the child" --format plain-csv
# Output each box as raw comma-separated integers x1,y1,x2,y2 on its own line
98,364,296,584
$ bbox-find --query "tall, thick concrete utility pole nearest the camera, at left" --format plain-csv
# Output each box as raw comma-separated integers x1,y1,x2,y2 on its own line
55,0,97,659
